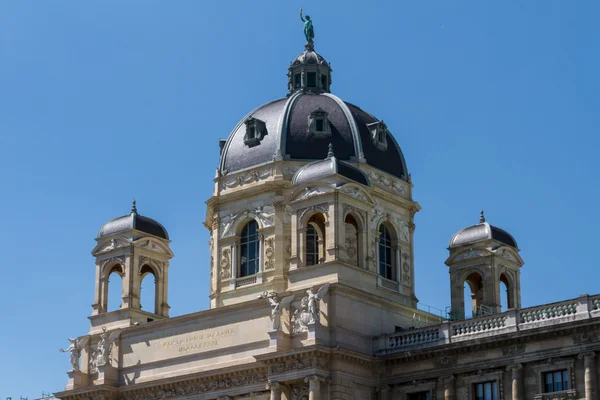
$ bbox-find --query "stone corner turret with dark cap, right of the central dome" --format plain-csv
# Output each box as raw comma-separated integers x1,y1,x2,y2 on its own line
446,211,523,320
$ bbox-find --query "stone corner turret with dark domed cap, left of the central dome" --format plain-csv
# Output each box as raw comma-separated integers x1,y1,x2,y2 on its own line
89,200,173,334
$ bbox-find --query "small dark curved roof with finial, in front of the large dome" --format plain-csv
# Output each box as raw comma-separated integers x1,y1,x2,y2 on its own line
292,145,370,186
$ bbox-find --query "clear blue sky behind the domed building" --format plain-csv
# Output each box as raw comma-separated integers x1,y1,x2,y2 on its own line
0,0,600,399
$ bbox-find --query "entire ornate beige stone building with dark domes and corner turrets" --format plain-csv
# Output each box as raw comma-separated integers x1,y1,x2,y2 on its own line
56,30,600,400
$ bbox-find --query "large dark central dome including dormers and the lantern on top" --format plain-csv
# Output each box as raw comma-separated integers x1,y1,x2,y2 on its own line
219,43,408,180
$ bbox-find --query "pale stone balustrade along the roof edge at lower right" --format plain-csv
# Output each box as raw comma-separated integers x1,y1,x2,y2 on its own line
373,294,600,355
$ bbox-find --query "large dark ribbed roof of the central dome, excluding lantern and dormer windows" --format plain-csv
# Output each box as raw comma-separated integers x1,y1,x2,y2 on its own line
219,91,408,180
